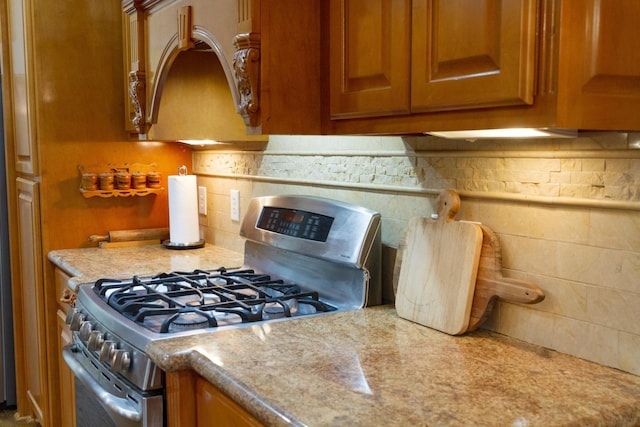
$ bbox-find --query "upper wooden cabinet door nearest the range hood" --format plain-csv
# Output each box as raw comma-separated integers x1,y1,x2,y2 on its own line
329,0,411,119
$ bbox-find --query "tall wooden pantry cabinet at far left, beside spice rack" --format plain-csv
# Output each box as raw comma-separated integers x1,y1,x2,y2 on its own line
0,0,138,427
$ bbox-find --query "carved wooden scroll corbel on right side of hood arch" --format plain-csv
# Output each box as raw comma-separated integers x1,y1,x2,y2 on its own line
233,33,260,126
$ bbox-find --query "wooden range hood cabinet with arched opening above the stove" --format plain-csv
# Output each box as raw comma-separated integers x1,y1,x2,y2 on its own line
122,0,321,141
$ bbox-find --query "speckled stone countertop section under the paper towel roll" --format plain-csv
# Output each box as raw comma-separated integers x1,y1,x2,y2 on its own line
47,245,244,290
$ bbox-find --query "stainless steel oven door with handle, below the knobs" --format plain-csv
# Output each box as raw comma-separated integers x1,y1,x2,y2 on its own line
62,344,164,427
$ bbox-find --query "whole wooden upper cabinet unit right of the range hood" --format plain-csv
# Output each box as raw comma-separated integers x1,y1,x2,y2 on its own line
324,0,640,134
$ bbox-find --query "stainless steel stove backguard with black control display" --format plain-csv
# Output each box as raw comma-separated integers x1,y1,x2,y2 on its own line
240,195,382,309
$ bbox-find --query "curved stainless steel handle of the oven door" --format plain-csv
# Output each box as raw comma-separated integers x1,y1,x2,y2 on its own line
62,344,142,422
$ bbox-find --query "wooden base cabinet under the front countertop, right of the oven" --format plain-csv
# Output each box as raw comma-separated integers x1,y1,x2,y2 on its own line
166,371,263,427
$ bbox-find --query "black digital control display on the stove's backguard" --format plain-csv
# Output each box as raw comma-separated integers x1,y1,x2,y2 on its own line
258,206,333,242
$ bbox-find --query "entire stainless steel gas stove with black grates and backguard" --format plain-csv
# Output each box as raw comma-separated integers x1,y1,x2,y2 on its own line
63,196,381,426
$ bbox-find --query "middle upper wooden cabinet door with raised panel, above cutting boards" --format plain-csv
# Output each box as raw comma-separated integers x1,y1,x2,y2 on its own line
411,0,537,112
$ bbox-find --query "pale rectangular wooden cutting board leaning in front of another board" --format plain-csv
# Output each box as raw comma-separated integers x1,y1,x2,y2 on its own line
396,190,482,335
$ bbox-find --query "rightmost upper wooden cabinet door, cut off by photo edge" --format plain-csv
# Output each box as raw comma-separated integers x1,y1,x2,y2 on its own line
558,0,640,130
